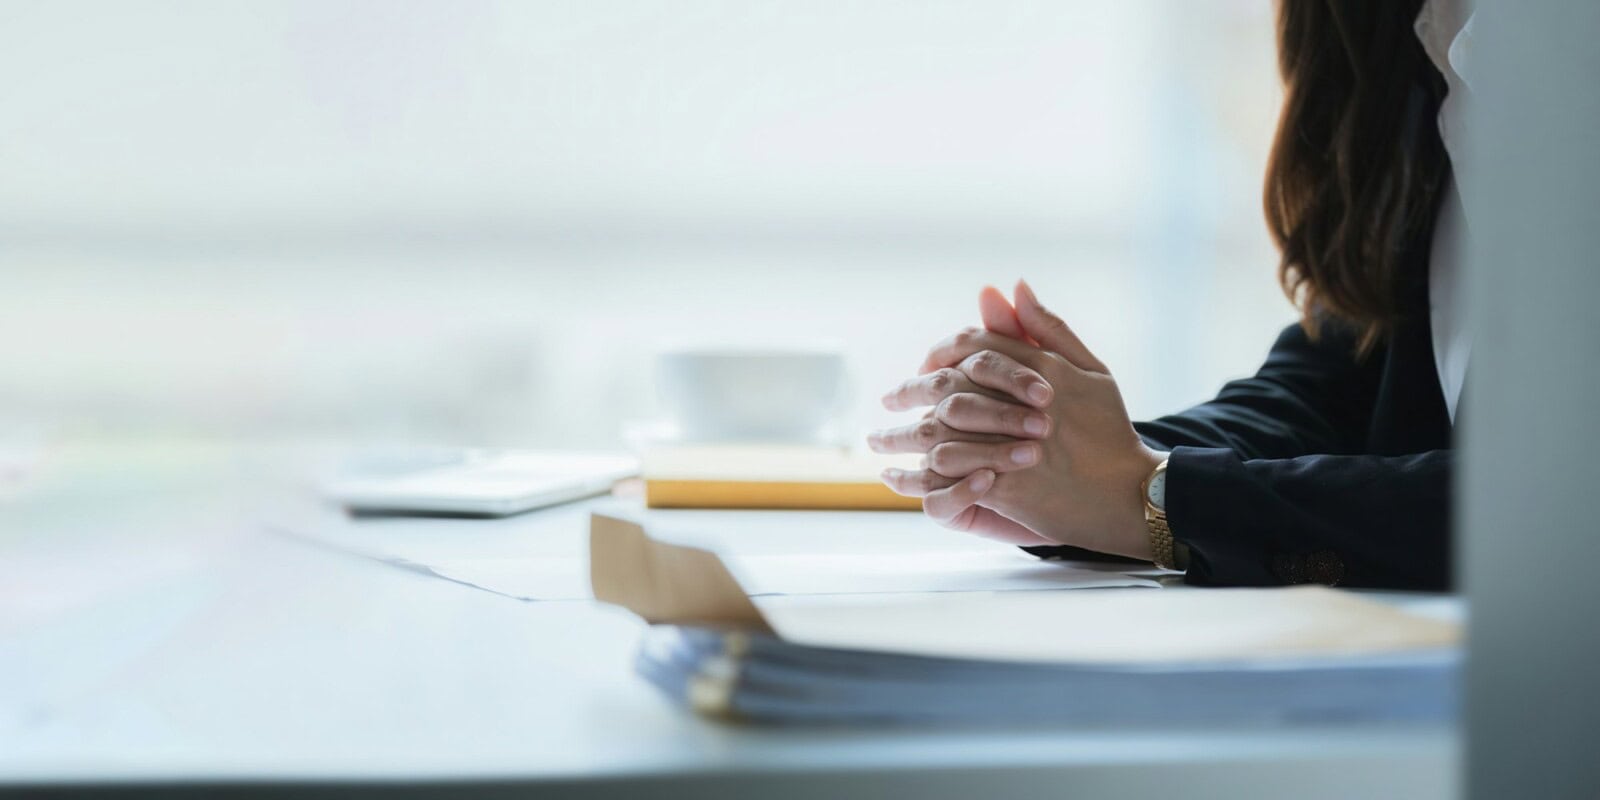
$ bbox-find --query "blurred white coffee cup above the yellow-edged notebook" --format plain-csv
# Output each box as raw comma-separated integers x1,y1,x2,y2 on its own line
656,349,845,442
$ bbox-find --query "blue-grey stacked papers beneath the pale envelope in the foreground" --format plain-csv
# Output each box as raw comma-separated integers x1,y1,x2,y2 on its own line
637,624,1459,725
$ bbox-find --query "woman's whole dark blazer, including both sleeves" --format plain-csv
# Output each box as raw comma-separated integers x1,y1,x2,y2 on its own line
1029,265,1453,589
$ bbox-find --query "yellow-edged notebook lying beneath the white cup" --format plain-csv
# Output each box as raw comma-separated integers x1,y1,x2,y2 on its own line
643,445,922,510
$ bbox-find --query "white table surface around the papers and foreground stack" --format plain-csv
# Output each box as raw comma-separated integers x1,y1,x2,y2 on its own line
0,453,1458,797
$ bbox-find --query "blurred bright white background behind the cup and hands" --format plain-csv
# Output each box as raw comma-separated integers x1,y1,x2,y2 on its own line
0,0,1293,446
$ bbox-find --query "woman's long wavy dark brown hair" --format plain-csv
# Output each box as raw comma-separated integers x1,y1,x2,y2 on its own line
1266,0,1450,352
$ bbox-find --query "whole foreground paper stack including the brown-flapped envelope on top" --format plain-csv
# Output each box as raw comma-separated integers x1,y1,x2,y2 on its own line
590,517,1461,725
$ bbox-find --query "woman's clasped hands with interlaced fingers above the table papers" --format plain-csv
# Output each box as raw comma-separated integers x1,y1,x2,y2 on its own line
867,282,1165,560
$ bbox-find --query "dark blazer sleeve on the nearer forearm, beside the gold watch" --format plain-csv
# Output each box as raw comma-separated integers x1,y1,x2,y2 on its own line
1166,446,1453,590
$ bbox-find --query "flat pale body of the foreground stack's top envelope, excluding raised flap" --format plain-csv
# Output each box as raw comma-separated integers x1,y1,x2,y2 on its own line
763,586,1461,664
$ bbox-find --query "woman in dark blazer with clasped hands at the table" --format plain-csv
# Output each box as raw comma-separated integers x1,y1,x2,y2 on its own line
869,0,1470,589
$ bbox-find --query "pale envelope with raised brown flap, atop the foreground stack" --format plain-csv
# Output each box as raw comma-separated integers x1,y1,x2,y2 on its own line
589,514,1461,664
